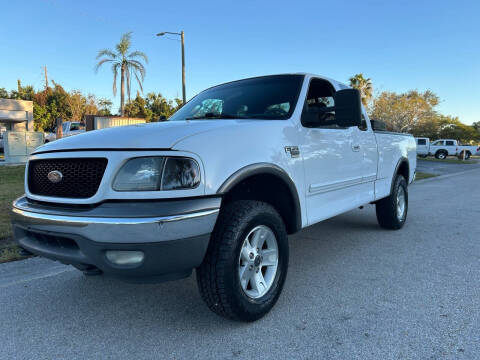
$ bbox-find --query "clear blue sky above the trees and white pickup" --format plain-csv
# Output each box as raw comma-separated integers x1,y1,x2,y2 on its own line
0,0,480,123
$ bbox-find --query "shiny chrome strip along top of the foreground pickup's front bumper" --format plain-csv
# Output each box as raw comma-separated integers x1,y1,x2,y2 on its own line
12,207,220,226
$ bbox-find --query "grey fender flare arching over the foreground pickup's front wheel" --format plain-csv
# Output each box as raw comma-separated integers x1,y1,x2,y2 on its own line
217,163,302,232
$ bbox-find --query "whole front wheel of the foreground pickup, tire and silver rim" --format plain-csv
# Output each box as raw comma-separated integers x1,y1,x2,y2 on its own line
197,200,288,321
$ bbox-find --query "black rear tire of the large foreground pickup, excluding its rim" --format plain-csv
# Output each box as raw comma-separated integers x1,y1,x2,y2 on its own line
376,175,408,230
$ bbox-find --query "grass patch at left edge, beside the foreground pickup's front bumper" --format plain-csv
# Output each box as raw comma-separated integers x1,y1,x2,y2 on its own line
0,165,25,263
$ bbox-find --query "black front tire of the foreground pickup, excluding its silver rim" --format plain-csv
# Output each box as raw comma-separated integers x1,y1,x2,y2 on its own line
196,200,289,321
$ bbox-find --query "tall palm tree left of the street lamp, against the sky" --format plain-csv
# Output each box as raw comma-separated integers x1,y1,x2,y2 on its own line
95,32,148,116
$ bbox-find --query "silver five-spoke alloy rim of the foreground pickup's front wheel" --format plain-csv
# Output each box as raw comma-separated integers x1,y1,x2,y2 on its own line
238,225,278,299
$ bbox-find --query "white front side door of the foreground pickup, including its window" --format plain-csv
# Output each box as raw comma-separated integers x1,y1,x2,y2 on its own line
300,78,373,224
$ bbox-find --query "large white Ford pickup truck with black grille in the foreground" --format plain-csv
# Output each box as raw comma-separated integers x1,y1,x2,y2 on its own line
12,74,416,321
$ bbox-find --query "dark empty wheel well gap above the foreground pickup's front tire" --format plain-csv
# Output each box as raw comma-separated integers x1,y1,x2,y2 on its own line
222,173,302,234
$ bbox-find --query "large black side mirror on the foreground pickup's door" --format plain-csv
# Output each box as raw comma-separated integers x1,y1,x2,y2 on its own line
333,89,362,127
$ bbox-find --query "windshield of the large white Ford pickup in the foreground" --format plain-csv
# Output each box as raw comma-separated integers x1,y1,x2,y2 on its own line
169,75,304,121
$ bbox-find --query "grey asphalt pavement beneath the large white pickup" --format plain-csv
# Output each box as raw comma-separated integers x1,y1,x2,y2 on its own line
0,170,480,359
